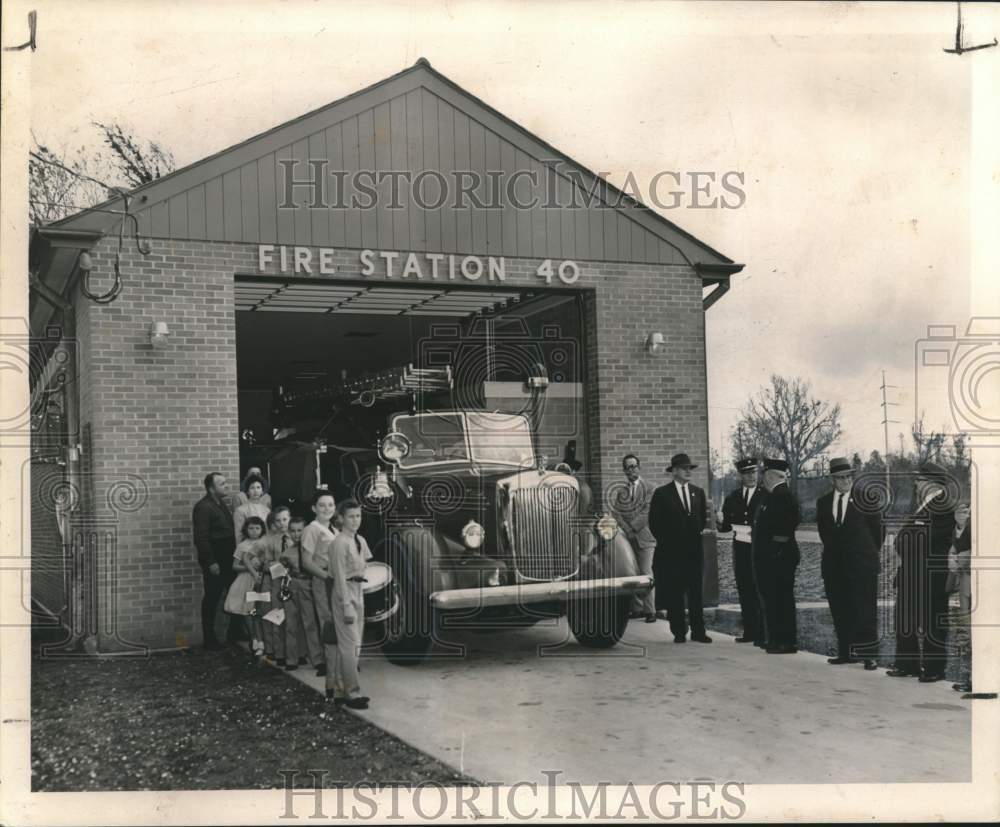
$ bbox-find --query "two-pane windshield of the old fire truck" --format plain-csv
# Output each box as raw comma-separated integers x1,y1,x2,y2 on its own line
393,411,535,469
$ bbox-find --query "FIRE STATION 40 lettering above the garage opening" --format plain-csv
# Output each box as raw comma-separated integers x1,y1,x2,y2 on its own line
257,244,580,284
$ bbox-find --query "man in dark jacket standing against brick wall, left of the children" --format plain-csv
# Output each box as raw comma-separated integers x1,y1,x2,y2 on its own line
191,472,237,649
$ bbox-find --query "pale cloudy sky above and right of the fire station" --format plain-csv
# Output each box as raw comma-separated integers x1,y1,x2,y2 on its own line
17,0,1000,466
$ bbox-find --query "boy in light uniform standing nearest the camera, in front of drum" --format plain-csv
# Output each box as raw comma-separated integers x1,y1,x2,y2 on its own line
319,500,372,709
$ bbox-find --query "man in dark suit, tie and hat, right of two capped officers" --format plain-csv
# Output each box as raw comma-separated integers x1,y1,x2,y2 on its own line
816,457,885,670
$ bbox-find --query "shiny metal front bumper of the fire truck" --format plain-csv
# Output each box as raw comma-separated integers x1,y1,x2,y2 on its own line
431,574,653,609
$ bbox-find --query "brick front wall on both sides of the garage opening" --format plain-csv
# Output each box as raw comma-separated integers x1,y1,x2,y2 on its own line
66,239,708,649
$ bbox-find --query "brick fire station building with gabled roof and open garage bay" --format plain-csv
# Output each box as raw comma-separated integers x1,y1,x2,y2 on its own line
31,60,742,651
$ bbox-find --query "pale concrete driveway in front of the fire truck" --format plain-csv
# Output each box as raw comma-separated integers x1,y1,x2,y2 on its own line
293,620,971,784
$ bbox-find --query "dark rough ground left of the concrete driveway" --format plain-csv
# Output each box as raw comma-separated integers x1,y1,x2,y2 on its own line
31,648,476,792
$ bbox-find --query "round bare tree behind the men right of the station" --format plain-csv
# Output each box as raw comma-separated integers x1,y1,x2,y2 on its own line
732,374,841,490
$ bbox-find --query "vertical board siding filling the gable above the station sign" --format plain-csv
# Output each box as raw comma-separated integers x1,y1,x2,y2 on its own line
113,79,716,264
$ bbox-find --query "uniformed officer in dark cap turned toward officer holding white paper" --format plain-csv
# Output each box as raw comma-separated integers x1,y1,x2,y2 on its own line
752,459,799,655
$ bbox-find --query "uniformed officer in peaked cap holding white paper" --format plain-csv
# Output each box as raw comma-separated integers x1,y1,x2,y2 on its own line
716,457,765,648
